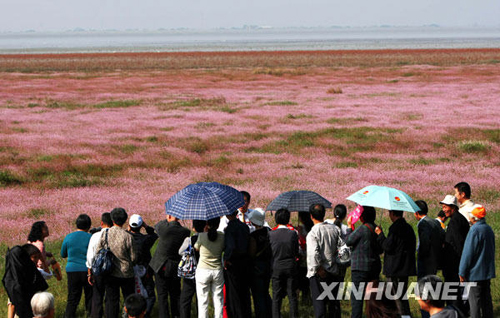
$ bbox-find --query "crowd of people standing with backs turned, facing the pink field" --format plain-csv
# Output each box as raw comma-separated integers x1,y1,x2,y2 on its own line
3,182,495,318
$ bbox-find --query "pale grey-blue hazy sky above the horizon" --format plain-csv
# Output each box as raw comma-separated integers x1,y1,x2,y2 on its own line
0,0,500,32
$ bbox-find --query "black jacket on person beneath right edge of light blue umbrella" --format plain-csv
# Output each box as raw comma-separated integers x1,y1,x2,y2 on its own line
377,218,417,277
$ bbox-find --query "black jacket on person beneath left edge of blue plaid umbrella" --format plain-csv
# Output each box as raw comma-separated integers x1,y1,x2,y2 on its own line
149,220,191,277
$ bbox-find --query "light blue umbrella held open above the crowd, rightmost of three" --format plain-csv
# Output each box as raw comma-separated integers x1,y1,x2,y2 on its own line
347,185,420,213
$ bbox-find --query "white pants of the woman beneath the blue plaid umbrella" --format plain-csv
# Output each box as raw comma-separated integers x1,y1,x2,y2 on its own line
195,268,224,318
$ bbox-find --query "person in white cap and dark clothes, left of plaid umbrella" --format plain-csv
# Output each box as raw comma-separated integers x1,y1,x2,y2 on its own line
128,214,158,318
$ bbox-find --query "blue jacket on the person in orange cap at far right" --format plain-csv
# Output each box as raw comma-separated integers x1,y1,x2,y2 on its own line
459,219,495,282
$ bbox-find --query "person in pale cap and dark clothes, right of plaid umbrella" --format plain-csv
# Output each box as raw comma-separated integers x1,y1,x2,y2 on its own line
248,209,273,318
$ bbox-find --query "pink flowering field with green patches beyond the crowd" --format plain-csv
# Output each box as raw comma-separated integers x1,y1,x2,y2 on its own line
0,51,500,245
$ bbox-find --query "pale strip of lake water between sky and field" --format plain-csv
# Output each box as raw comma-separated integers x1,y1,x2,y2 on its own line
0,27,500,54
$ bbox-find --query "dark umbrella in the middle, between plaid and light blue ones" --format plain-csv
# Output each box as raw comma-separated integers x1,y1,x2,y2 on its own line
266,190,332,212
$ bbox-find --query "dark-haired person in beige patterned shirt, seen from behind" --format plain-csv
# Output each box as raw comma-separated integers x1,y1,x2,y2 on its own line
97,208,137,318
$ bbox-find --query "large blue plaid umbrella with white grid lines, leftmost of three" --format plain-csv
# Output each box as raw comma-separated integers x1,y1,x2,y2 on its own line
165,182,245,220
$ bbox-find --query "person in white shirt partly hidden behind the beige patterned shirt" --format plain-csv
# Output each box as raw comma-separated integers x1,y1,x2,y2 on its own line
86,212,113,318
